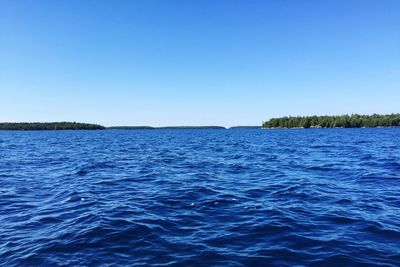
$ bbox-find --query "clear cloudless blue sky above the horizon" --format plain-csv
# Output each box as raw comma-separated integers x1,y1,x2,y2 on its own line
0,0,400,126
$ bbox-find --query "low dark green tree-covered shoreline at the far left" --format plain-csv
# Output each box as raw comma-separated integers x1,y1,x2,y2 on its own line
0,122,105,130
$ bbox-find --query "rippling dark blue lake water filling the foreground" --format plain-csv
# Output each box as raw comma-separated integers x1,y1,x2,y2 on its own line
0,129,400,266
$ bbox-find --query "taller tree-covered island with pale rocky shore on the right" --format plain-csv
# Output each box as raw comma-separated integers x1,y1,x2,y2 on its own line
262,114,400,128
